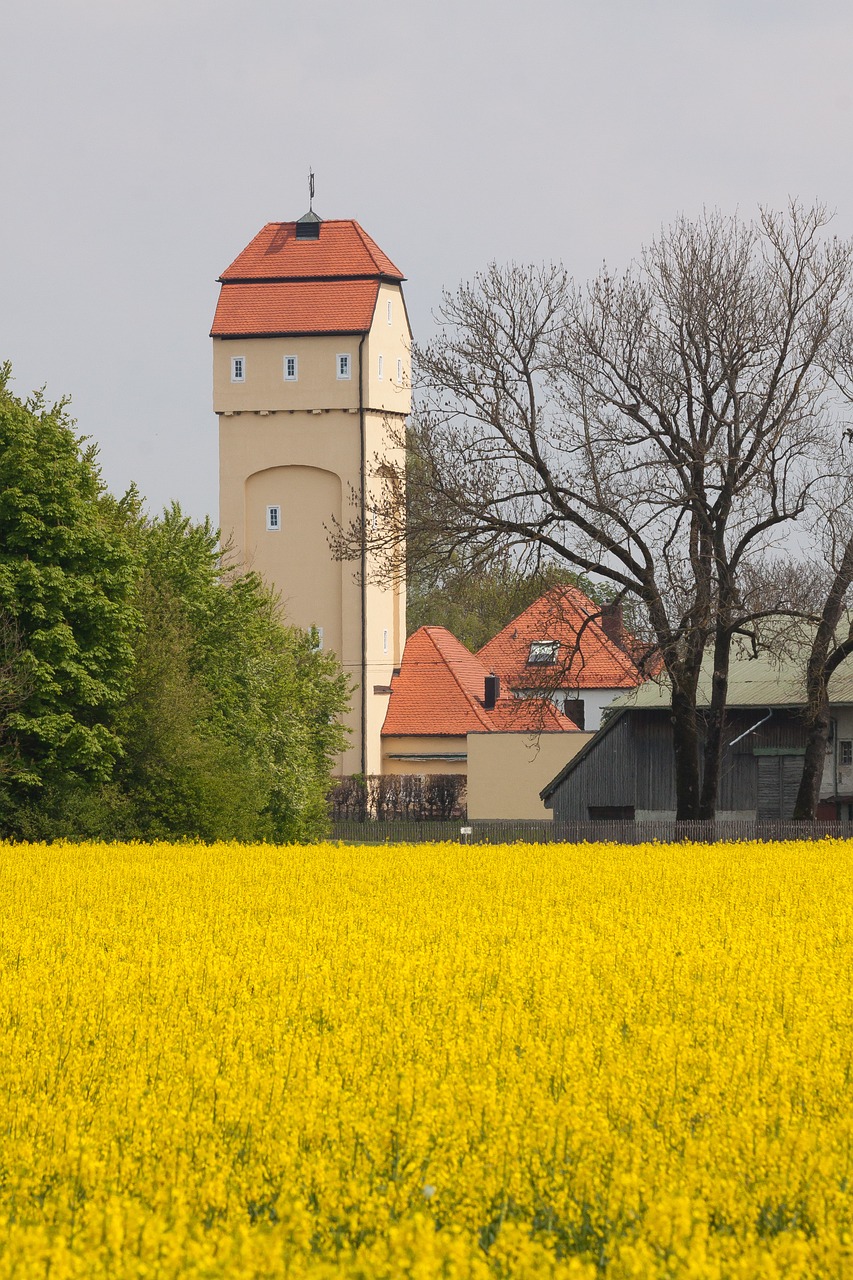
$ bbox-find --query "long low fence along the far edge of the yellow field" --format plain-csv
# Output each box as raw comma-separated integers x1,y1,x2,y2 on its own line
326,818,853,845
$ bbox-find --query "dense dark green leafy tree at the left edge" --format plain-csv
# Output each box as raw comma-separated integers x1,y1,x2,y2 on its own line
0,364,137,826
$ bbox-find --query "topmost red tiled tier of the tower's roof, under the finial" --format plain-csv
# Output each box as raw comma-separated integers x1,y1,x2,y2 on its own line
220,218,403,280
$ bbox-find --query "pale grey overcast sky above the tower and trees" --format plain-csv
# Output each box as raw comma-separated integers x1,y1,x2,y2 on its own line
0,0,853,520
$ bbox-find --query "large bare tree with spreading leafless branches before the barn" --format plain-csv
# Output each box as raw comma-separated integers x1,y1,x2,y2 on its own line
342,204,853,818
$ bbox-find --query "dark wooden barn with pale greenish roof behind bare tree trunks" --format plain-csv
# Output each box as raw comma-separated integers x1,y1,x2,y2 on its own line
540,659,853,822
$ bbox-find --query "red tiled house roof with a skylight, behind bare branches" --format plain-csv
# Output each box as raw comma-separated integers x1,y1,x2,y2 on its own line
478,586,643,690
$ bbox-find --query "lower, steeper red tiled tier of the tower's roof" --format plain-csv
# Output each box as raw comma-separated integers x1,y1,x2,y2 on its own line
210,280,379,338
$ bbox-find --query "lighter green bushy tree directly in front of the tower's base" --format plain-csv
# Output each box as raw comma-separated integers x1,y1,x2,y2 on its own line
120,506,348,841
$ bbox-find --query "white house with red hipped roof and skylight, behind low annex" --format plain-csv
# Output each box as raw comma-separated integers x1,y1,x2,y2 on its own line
476,585,646,730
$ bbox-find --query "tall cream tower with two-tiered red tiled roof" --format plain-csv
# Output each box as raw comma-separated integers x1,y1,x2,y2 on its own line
210,207,411,774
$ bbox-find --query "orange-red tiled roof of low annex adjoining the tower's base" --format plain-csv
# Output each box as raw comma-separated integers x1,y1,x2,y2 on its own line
382,627,578,737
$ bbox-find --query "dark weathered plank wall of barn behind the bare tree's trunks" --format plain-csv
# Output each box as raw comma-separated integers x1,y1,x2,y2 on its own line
553,708,806,822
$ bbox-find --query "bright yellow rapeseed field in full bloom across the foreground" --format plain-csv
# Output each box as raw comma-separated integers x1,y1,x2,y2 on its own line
0,841,853,1280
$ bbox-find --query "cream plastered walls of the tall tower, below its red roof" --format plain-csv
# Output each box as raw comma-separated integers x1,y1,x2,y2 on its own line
214,284,410,773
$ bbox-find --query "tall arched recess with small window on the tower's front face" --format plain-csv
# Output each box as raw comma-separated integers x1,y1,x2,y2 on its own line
245,466,343,657
